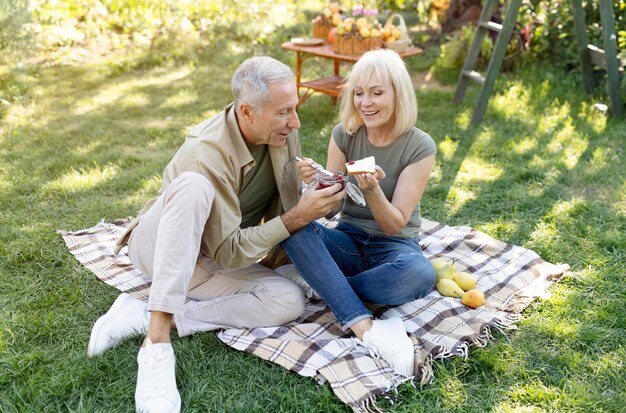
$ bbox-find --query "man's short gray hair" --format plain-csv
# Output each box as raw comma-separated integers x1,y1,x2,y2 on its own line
231,56,293,114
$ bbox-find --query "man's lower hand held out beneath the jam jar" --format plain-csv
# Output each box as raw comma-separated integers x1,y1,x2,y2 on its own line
281,184,346,234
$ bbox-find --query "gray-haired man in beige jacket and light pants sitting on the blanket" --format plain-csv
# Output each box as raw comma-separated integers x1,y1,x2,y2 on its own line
88,57,345,412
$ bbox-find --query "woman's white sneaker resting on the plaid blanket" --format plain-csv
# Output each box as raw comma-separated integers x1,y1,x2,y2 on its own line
363,317,415,376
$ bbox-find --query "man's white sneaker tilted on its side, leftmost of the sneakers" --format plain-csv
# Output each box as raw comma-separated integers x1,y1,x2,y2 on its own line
87,293,148,357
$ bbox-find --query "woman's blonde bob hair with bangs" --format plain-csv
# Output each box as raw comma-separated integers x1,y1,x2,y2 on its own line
339,49,417,137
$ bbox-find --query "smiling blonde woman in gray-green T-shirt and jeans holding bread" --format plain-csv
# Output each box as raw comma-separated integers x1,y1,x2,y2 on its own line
282,50,436,375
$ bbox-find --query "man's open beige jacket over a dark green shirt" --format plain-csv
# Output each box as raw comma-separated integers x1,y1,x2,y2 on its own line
115,104,300,268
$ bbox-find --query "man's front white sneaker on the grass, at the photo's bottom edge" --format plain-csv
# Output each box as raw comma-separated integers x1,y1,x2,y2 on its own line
135,338,180,413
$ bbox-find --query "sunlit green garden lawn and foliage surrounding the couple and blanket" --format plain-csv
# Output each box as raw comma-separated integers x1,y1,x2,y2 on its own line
0,0,626,412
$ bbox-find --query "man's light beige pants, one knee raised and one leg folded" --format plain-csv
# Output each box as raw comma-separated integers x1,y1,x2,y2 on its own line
128,172,304,336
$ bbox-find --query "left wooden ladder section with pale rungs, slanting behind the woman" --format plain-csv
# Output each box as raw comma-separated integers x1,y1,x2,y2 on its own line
454,0,522,123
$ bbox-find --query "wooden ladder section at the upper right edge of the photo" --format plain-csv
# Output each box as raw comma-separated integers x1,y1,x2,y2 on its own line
572,0,624,117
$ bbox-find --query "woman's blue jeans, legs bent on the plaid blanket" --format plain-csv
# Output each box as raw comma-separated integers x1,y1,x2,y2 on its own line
281,222,435,329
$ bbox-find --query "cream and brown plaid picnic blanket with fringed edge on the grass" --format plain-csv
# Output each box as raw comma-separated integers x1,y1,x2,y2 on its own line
58,219,569,412
